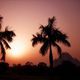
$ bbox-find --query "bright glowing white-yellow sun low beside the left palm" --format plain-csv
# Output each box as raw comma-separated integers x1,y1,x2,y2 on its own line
9,41,25,58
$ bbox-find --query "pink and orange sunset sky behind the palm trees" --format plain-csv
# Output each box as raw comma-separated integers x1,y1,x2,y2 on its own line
0,0,80,64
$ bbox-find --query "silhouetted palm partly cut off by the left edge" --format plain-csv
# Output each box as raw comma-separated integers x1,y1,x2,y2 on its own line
0,17,15,62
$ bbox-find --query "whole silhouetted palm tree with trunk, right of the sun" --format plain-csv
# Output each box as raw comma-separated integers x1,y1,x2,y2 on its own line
32,16,70,67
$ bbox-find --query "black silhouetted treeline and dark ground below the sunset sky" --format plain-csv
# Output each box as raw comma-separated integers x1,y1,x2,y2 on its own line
0,61,80,80
